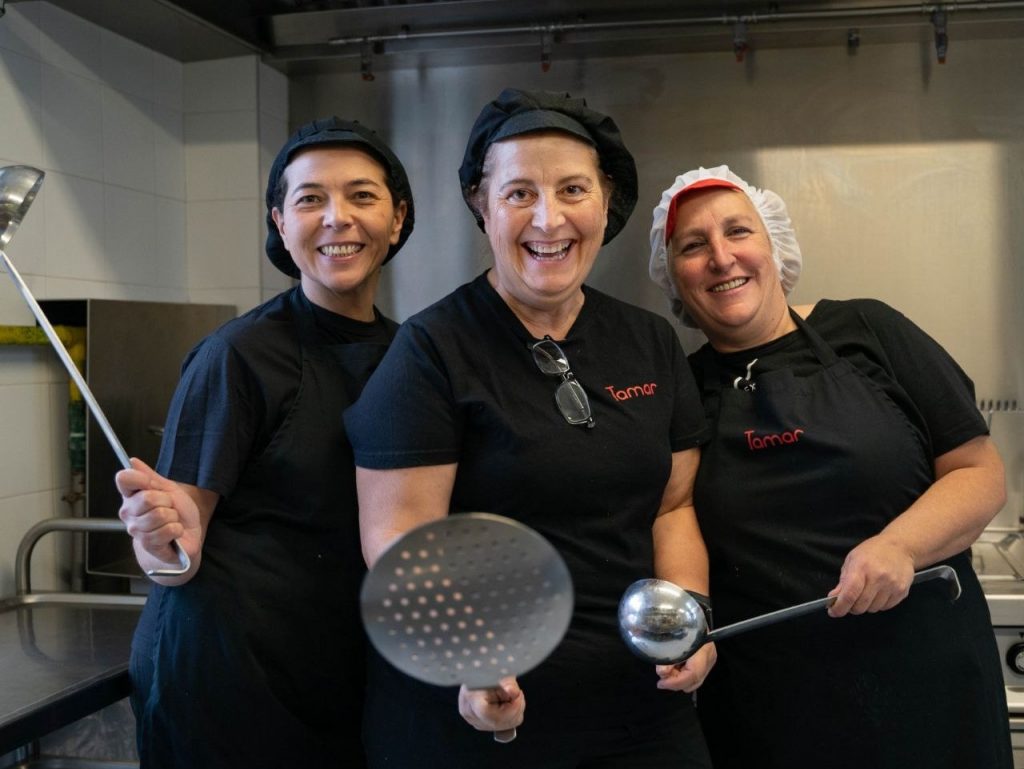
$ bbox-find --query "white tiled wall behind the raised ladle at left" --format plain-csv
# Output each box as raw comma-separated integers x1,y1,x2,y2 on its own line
0,2,290,596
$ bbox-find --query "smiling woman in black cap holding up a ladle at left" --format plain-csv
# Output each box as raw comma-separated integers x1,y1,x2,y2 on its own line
117,118,413,769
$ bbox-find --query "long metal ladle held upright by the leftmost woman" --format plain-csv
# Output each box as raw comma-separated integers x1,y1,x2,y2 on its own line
0,166,191,576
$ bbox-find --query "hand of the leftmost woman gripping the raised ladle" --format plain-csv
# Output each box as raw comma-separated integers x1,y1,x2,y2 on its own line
115,459,205,584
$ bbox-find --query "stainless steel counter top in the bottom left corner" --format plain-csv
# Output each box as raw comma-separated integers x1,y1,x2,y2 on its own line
0,594,141,755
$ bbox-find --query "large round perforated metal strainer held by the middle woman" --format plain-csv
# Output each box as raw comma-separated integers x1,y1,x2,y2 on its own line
360,513,572,742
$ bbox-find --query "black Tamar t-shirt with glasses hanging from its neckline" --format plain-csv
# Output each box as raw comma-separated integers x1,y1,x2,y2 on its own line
345,274,707,718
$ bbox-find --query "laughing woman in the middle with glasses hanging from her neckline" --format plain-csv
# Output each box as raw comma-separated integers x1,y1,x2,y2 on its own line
345,89,714,769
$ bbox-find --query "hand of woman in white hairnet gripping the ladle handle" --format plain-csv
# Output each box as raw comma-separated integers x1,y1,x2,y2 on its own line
828,537,913,616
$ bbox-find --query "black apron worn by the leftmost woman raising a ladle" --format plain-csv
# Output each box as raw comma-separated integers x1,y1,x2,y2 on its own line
133,292,386,769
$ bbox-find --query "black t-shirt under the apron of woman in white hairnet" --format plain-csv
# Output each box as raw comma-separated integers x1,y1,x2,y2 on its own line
690,299,988,459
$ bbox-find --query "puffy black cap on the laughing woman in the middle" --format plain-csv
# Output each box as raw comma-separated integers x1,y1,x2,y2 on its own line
459,88,637,243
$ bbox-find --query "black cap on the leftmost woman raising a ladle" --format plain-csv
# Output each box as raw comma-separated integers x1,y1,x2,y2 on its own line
266,117,415,277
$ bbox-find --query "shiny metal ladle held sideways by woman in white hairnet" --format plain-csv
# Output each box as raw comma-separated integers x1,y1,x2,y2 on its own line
618,565,961,665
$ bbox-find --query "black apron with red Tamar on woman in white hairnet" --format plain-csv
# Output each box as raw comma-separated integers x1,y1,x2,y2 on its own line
694,310,1012,769
